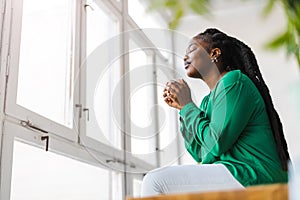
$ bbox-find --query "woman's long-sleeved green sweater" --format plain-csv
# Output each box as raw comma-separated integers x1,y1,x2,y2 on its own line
179,70,287,186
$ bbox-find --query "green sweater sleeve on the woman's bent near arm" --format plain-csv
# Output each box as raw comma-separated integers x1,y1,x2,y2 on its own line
179,81,255,163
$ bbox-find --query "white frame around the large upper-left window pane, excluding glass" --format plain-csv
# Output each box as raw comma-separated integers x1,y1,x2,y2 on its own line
3,0,79,141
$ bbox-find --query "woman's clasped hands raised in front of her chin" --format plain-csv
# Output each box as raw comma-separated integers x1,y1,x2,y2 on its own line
163,79,192,110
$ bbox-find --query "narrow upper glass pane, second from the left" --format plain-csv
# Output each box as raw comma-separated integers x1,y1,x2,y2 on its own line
86,0,121,149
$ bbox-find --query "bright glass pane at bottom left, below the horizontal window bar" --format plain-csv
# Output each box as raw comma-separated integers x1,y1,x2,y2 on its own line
11,141,122,200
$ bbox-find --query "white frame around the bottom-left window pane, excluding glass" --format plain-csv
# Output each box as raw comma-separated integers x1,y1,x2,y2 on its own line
0,120,125,200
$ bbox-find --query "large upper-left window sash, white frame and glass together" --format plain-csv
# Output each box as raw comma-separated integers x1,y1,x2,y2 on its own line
4,0,78,141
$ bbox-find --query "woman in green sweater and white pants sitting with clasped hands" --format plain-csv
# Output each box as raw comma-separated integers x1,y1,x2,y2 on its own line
142,29,289,196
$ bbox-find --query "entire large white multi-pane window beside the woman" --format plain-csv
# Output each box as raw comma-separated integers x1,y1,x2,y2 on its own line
0,0,173,200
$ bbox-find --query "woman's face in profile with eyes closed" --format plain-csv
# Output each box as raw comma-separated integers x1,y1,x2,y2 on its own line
184,38,212,79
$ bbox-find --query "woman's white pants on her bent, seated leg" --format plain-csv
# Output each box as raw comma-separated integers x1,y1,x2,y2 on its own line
141,164,244,197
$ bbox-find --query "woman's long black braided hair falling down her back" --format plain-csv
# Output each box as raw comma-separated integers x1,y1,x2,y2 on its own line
195,29,290,170
